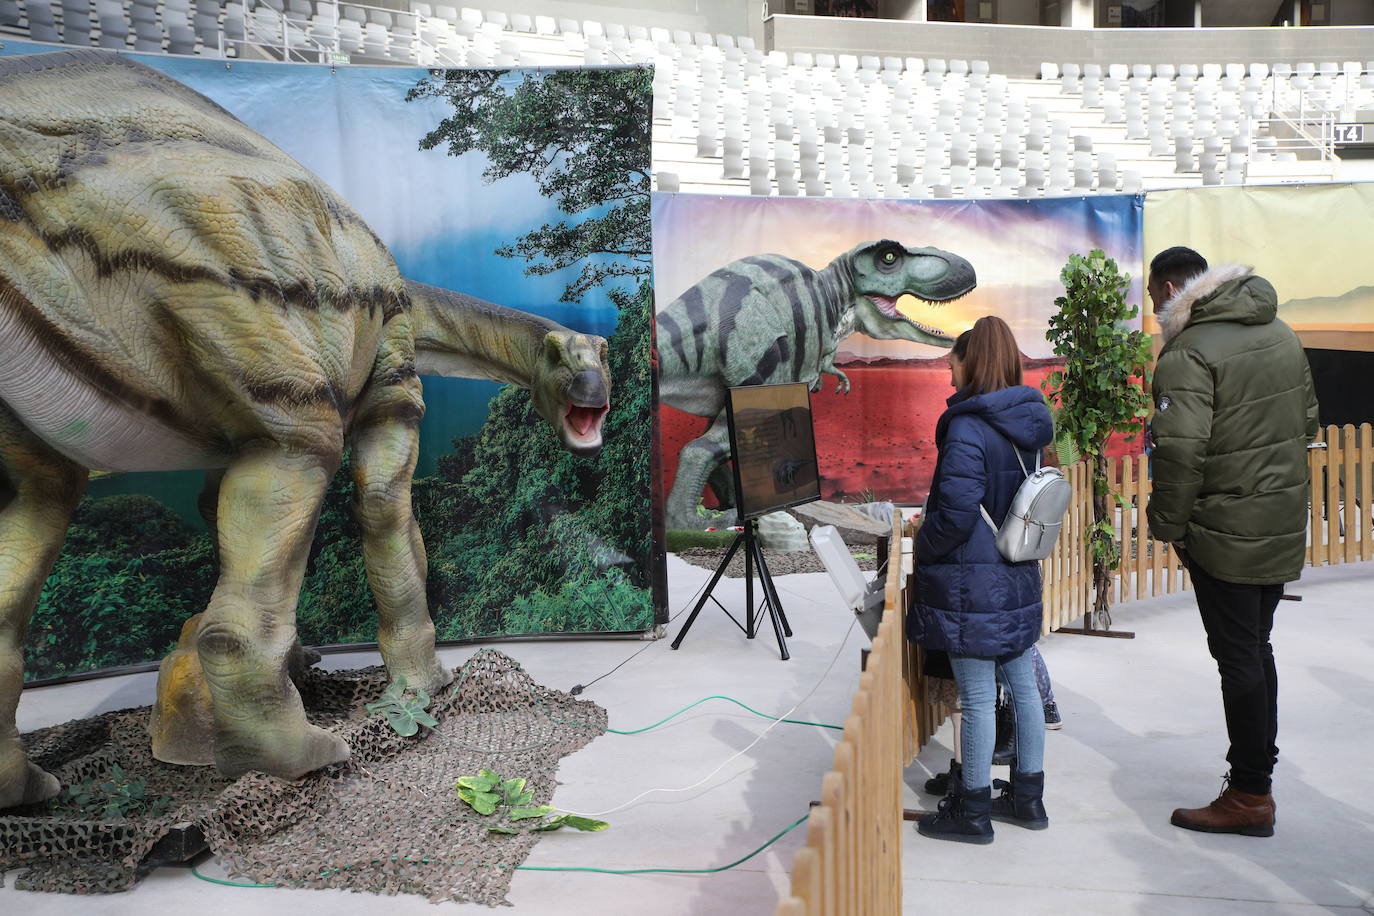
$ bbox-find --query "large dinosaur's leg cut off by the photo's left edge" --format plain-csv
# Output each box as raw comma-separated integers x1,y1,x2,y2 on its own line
0,402,87,809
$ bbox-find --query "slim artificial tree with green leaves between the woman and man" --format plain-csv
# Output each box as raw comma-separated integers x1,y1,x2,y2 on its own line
1041,250,1150,629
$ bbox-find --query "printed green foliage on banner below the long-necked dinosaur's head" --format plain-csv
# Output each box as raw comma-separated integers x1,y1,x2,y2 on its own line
414,283,653,639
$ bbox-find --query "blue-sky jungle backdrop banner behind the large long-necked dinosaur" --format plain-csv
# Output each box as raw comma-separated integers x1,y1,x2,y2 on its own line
0,41,666,680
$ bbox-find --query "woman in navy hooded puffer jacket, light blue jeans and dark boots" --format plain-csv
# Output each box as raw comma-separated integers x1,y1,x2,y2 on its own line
907,316,1054,843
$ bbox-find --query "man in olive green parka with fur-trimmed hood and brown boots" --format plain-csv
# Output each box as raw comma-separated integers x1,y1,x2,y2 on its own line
1149,249,1318,836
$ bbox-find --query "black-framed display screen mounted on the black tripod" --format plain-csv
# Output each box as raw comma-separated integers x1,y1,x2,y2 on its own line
725,382,820,520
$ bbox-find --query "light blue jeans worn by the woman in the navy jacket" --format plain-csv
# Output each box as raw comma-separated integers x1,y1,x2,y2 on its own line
949,650,1044,790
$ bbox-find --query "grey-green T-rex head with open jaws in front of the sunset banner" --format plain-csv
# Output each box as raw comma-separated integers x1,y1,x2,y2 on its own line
849,239,978,347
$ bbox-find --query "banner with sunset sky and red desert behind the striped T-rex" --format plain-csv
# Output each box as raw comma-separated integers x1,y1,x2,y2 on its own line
654,194,1143,516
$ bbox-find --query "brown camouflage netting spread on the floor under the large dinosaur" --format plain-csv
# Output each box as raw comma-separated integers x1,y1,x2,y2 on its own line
0,650,606,905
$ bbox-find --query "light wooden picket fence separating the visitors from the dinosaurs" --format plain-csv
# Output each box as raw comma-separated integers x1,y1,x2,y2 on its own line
776,423,1374,916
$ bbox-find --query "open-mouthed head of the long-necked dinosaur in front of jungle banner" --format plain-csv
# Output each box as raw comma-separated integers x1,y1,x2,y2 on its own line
530,331,610,456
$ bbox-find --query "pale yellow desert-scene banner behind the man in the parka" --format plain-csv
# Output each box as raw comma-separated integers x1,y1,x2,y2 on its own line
1145,183,1374,426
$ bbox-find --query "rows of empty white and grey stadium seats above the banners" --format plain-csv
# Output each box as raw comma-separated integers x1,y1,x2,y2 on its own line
0,0,1335,196
